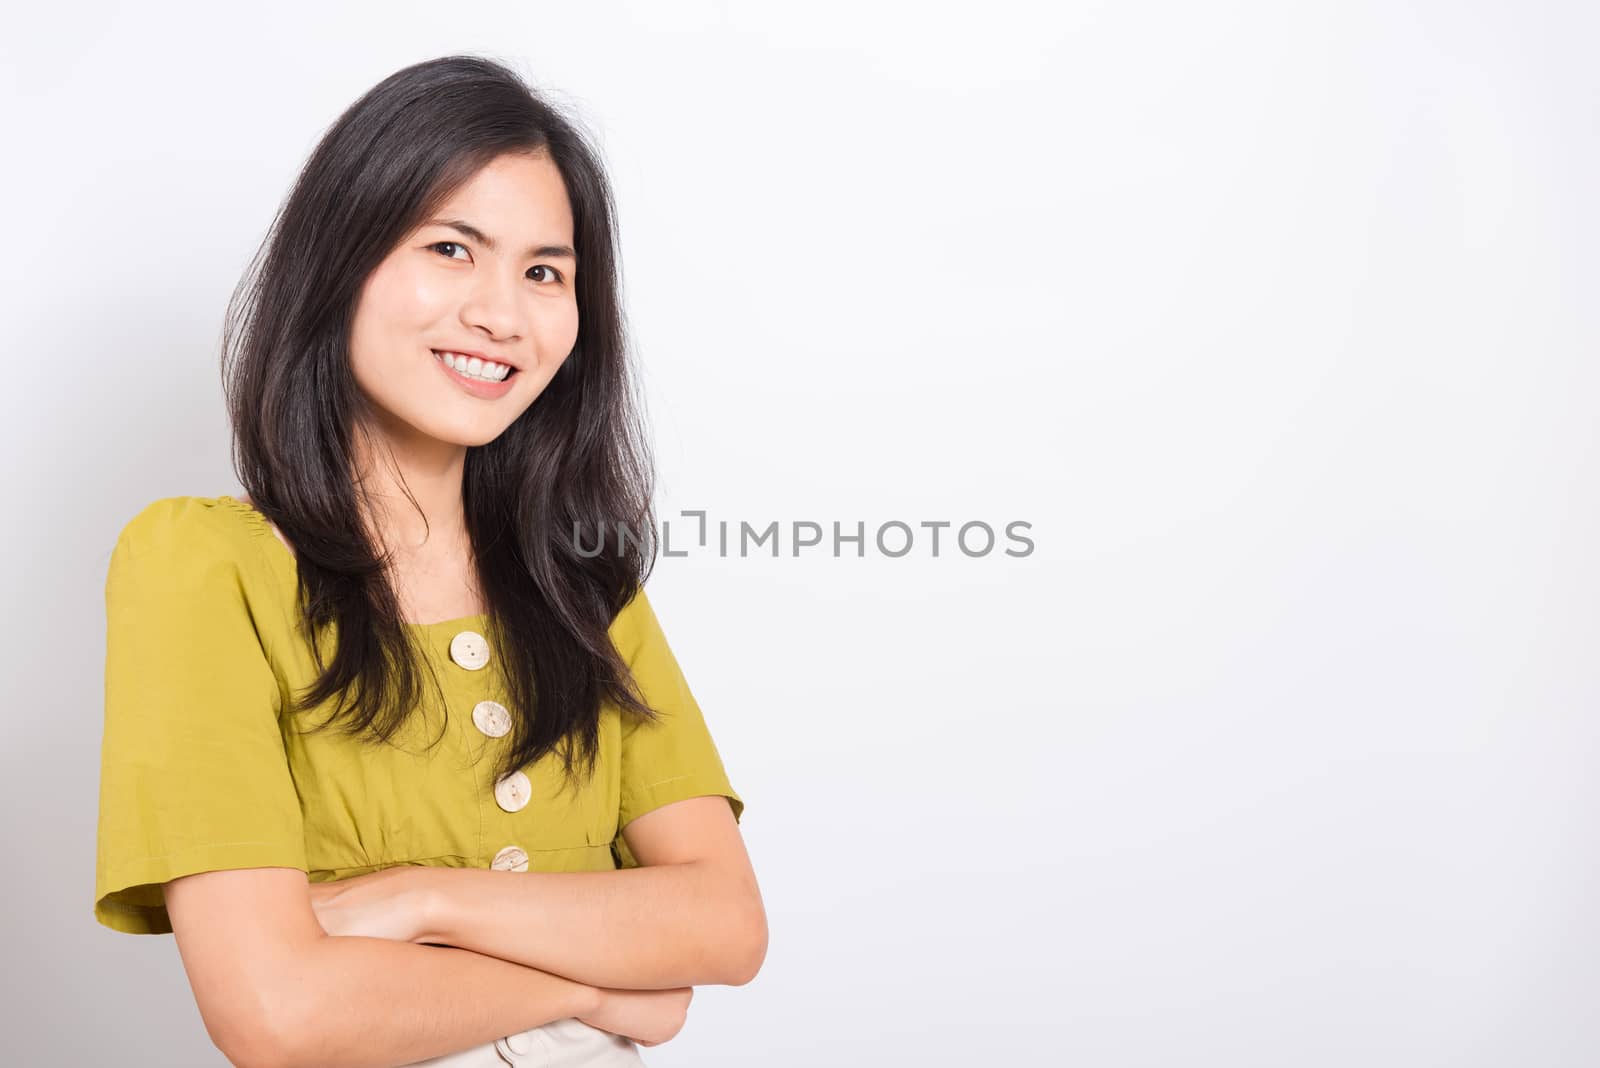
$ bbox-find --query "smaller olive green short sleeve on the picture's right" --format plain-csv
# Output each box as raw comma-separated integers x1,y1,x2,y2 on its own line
613,587,744,867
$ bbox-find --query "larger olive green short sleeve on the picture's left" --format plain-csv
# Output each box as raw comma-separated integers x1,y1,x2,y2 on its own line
94,497,306,934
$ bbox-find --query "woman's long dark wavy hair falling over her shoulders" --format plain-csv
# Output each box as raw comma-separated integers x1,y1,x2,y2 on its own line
222,56,656,787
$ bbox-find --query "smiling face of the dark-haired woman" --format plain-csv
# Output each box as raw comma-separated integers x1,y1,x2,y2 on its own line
350,155,578,448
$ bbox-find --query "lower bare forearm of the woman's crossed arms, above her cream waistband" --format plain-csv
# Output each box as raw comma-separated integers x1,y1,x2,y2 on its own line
261,935,600,1068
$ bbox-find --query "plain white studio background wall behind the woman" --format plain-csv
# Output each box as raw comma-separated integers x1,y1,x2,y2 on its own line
0,0,1600,1068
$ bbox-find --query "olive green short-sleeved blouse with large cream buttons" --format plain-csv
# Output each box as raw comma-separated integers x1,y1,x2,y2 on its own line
94,496,744,934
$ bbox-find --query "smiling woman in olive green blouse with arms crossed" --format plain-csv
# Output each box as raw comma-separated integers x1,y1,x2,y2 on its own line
94,56,766,1068
